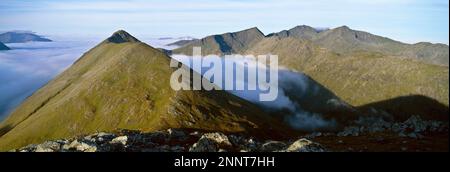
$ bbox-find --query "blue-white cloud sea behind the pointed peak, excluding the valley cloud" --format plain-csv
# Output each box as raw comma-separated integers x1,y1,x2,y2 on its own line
0,36,190,121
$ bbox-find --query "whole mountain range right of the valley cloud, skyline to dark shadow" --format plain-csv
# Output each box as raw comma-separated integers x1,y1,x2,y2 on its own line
173,25,449,119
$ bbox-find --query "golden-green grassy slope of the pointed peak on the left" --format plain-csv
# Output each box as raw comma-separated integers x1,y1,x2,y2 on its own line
0,31,288,150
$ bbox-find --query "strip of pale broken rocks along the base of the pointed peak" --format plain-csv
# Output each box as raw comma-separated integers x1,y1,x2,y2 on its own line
12,129,326,152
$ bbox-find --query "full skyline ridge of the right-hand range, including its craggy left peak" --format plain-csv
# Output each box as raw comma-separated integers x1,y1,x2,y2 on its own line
173,25,449,66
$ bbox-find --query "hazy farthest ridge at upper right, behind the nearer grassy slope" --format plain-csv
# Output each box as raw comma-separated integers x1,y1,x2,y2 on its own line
269,26,449,66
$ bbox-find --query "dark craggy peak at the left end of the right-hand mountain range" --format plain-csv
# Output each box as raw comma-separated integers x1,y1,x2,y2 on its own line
173,28,264,55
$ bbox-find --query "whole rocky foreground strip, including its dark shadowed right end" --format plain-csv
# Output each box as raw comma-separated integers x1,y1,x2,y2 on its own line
11,116,448,152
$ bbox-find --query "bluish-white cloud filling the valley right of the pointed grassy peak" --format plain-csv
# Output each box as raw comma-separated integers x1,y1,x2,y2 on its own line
172,55,336,130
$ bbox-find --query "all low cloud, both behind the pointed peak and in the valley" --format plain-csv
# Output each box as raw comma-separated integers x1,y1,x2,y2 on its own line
0,38,335,130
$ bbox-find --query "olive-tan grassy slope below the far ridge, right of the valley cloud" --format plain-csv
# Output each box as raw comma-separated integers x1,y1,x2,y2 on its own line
246,37,449,119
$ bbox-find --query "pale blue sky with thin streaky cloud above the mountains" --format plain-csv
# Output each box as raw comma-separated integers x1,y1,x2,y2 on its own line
0,0,449,44
